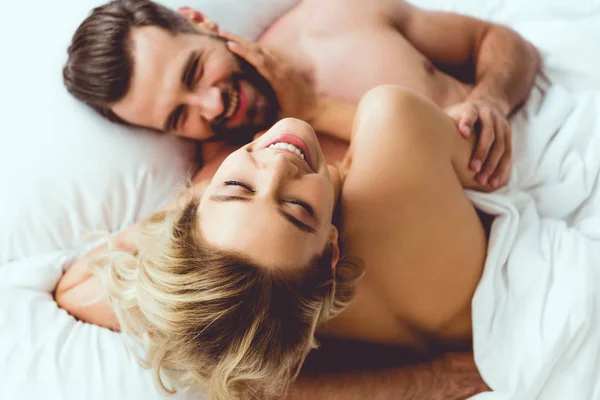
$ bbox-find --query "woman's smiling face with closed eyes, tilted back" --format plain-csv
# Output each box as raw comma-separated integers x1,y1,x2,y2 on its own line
199,118,340,271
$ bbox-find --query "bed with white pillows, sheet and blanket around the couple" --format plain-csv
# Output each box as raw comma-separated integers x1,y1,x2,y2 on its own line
0,0,600,400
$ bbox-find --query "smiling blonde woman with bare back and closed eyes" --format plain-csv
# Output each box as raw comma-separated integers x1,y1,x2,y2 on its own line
57,41,494,399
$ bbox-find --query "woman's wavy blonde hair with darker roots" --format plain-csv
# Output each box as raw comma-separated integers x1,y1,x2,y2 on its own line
97,194,362,400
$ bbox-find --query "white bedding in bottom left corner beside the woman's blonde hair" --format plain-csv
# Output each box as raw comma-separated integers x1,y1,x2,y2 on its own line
0,252,198,400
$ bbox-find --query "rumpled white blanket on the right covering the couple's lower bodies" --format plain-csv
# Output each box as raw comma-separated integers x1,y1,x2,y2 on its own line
470,70,600,400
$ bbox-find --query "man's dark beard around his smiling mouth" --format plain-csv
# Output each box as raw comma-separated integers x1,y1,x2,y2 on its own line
210,54,279,146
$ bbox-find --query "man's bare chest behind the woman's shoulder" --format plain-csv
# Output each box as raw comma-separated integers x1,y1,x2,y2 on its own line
261,3,449,101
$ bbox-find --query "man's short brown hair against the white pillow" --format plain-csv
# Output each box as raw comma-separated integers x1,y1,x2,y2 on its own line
63,0,199,124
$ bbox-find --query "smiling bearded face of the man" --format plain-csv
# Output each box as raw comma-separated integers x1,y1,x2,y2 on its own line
112,26,278,144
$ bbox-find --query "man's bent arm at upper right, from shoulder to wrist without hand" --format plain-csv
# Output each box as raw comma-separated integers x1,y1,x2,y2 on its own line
389,0,540,115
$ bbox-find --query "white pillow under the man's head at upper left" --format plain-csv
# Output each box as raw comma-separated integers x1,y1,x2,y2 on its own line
0,0,296,265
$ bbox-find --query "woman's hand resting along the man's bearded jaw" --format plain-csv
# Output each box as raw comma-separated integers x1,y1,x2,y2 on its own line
219,30,319,123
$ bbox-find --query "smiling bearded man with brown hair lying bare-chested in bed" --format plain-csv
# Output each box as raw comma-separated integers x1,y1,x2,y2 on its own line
59,0,539,399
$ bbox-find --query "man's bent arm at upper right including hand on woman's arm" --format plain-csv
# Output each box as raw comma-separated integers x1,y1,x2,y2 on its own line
385,0,540,189
